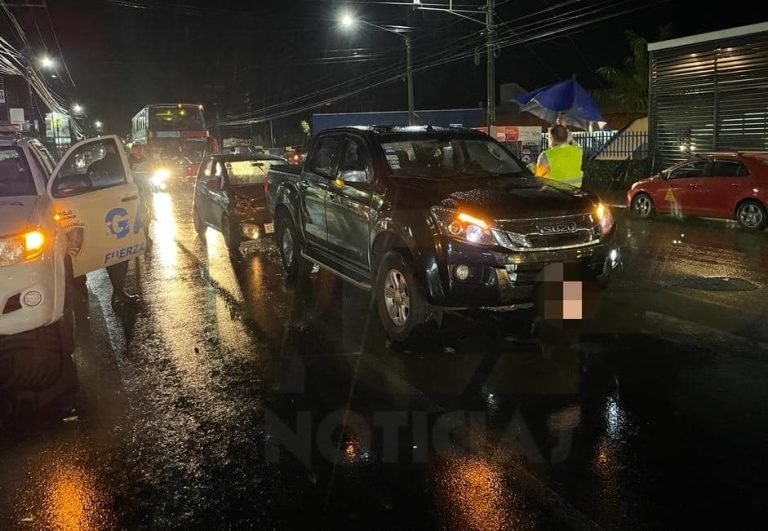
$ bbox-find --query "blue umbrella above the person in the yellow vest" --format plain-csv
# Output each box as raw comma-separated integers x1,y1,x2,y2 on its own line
515,78,603,129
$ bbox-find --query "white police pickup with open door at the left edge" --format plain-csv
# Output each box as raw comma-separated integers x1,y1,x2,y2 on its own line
0,136,145,390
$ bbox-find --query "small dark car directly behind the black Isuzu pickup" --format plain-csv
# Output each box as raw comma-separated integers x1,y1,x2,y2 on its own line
192,153,288,250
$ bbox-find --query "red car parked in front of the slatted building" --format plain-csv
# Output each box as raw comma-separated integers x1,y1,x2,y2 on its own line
627,152,768,230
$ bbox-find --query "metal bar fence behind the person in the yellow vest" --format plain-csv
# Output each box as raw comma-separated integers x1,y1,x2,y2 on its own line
541,131,648,160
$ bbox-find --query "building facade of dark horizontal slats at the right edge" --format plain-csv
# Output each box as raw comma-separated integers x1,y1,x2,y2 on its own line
648,22,768,170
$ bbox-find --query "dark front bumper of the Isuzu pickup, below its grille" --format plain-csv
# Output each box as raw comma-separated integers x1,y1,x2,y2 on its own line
423,237,621,310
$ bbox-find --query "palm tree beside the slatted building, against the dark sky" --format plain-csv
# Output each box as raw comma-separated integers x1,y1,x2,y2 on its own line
595,26,672,112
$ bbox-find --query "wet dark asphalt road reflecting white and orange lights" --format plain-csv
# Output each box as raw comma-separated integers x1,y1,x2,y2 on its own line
0,191,768,529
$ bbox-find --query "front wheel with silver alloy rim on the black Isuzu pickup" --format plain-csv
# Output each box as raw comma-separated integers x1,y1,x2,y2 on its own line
374,251,427,342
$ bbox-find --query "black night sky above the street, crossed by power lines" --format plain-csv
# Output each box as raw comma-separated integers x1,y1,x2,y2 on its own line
3,0,760,142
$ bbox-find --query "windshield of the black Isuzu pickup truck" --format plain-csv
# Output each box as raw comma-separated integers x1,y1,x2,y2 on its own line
382,138,525,179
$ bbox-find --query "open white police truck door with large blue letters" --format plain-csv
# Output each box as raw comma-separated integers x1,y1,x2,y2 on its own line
48,135,146,277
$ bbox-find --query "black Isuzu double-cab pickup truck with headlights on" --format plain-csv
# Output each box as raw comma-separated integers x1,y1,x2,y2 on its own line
267,126,619,341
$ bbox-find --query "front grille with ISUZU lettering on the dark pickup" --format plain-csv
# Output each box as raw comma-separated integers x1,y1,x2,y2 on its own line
496,214,600,251
